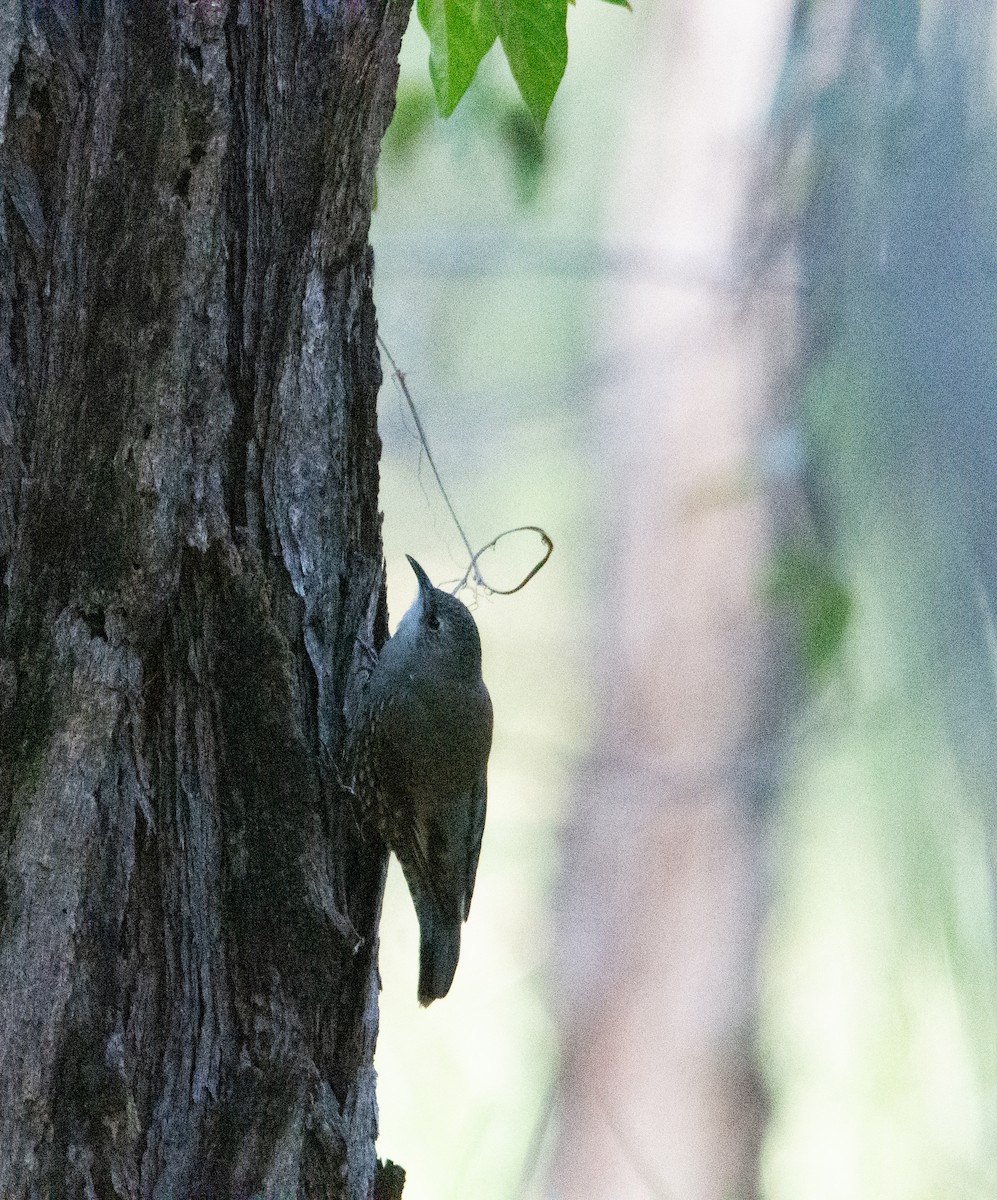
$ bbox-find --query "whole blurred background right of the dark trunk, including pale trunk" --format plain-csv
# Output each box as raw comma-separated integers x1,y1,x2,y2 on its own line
372,0,997,1200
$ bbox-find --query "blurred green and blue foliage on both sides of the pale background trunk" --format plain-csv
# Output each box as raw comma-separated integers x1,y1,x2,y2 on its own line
373,0,997,1200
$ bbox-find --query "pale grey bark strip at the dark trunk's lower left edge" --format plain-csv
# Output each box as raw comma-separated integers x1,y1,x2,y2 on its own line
0,618,138,1196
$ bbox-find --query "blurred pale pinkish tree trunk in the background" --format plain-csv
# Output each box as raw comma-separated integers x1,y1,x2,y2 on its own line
548,0,793,1200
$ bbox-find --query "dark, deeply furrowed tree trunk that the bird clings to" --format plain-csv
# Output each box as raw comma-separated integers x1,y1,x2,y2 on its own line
0,0,408,1200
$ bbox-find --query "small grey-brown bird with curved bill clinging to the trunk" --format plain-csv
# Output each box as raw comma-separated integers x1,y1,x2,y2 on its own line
355,554,493,1007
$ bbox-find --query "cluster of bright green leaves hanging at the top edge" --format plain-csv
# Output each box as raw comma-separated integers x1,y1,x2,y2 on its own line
418,0,630,126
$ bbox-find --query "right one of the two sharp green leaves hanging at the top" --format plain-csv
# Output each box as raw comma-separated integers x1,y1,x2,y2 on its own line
494,0,567,126
